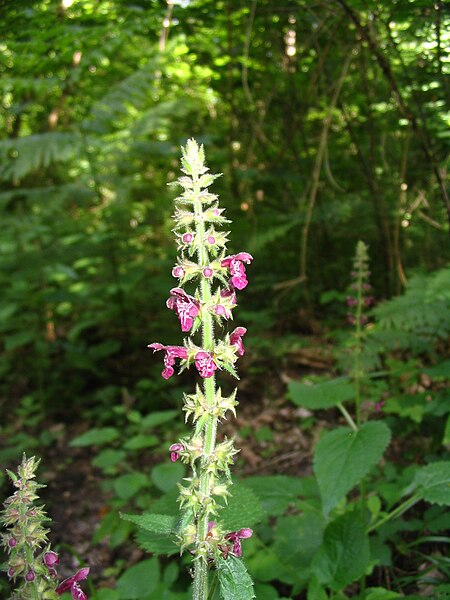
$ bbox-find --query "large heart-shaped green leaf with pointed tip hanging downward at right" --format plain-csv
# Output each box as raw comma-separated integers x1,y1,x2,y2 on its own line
314,421,391,515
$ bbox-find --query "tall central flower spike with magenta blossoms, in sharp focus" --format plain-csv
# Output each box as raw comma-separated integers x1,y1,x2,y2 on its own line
149,139,252,600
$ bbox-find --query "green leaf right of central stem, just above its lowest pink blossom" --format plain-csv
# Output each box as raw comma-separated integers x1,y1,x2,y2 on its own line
219,483,264,531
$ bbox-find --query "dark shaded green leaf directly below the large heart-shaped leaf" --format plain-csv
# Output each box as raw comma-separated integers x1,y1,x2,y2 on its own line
312,513,370,591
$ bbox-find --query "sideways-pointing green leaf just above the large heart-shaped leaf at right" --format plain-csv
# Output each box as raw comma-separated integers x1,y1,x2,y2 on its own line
288,377,355,410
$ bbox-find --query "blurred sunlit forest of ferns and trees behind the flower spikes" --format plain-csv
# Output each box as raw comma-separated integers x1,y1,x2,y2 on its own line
0,0,450,600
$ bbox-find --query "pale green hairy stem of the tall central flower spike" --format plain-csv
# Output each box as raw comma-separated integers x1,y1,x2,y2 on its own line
193,176,217,600
